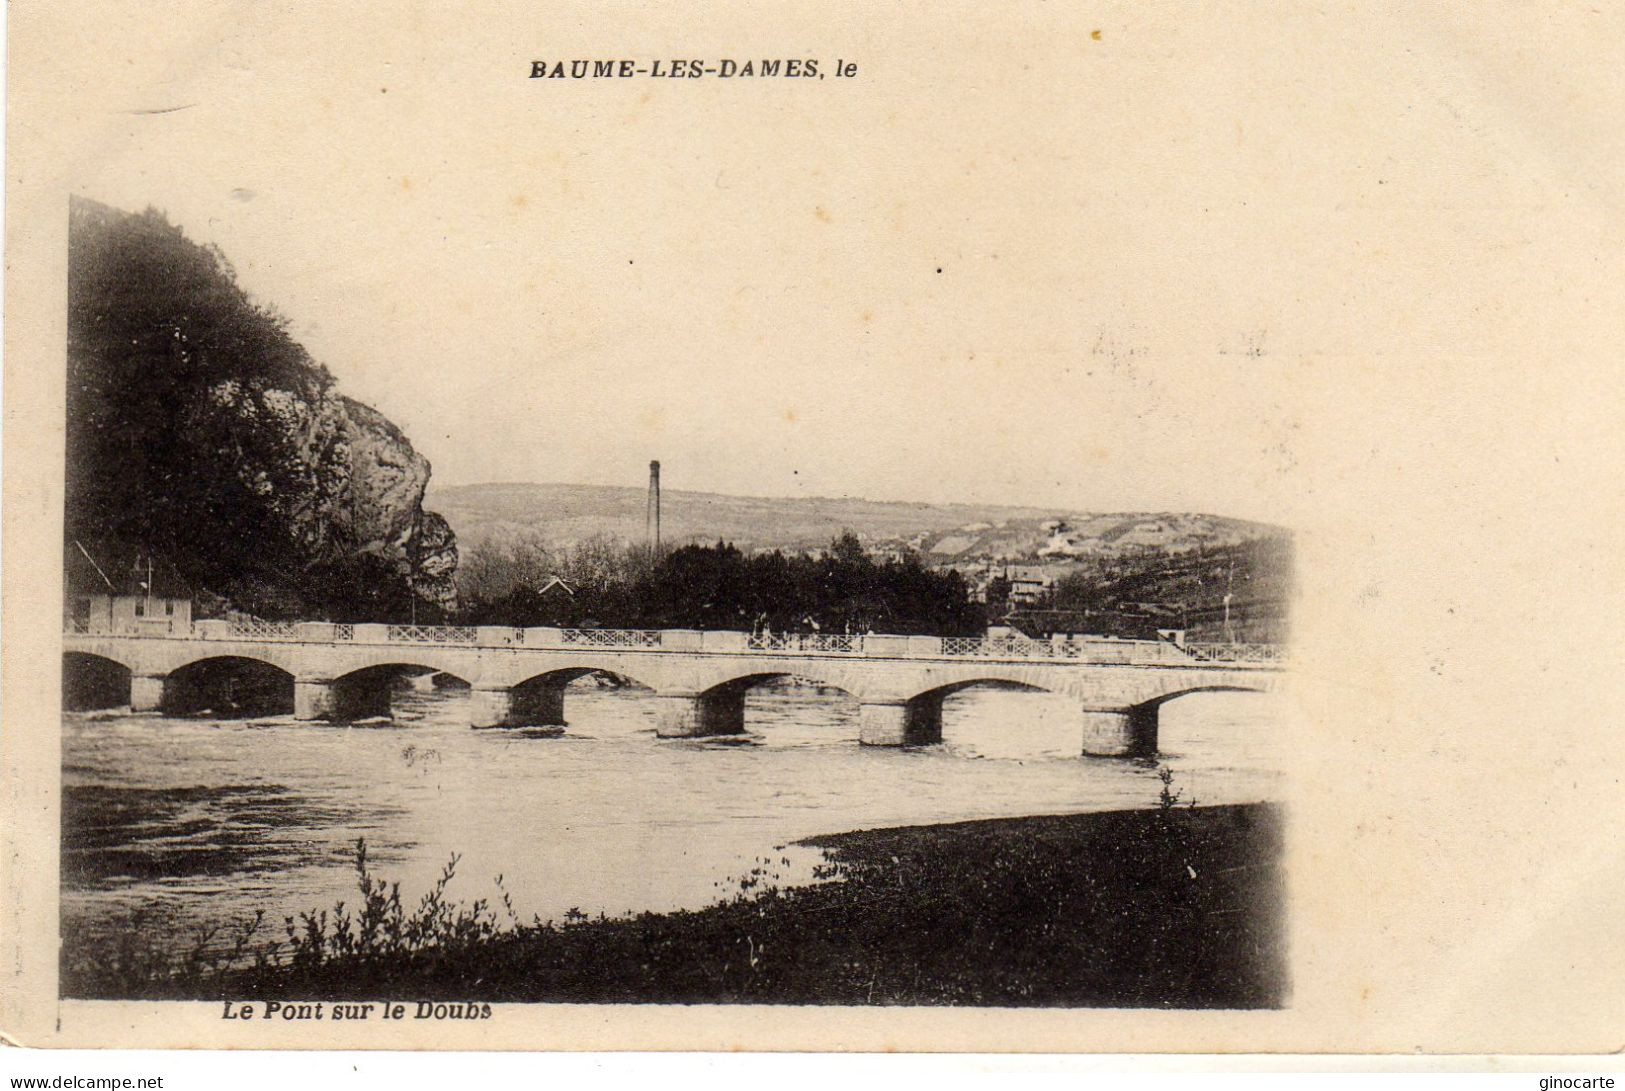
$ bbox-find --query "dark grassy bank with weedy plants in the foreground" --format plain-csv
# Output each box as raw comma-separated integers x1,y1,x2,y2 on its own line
63,805,1284,1006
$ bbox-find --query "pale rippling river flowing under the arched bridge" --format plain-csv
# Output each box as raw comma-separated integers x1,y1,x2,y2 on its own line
62,678,1281,948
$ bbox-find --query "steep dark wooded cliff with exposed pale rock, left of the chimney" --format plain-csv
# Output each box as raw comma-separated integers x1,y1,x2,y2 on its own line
67,200,457,621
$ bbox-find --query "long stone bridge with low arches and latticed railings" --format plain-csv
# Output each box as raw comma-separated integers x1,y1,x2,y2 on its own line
63,621,1282,756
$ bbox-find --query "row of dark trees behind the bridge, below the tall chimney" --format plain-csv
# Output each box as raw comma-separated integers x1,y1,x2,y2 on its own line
458,532,986,636
